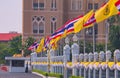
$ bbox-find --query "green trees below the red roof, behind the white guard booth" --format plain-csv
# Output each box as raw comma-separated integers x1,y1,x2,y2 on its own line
0,36,35,63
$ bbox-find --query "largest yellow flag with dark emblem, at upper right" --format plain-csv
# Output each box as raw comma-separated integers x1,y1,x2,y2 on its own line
95,0,118,23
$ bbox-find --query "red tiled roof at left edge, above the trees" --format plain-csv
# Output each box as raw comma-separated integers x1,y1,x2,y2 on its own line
0,33,21,41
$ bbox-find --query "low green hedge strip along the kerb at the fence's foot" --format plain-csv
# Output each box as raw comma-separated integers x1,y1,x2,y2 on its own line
32,69,63,78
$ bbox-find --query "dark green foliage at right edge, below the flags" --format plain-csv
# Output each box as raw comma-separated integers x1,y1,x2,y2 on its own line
109,26,120,49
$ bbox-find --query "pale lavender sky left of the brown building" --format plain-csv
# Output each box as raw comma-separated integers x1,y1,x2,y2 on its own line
0,0,22,33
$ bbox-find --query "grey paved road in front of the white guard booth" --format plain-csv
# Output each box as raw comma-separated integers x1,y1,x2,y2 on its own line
0,71,42,78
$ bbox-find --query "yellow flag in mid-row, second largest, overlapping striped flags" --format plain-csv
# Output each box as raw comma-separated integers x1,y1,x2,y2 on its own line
74,10,94,33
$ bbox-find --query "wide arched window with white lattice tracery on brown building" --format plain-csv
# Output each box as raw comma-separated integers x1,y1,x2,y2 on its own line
32,16,45,34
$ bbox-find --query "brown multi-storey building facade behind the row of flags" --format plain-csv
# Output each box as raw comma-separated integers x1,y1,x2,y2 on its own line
23,0,106,42
